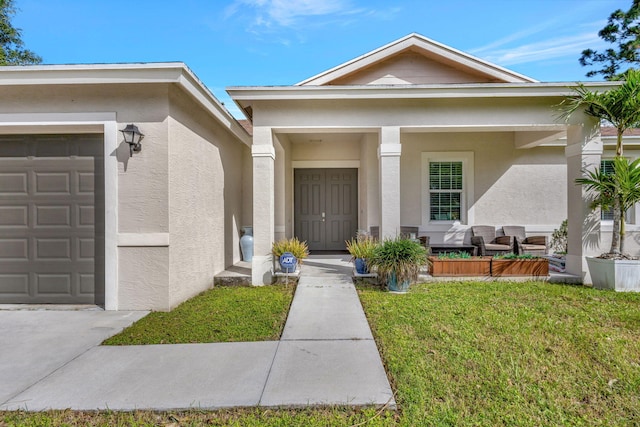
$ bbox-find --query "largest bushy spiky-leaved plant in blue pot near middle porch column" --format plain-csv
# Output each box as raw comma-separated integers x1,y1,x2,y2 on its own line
370,237,429,293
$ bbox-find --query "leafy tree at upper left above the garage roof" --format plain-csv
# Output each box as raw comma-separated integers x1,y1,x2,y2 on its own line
0,0,42,65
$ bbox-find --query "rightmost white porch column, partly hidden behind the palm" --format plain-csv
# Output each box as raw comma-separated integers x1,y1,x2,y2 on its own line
565,116,602,284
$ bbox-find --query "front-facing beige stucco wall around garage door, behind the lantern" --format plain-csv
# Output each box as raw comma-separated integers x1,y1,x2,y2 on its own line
0,84,174,310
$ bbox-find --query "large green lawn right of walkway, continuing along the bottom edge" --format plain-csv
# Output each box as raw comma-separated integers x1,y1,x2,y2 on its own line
5,282,640,426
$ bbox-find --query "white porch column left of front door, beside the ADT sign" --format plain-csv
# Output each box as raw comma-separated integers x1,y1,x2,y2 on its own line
251,127,276,286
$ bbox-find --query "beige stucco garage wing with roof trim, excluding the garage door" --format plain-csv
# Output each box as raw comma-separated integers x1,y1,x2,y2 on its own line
0,64,251,310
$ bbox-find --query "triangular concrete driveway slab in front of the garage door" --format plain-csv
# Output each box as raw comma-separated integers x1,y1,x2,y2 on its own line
0,308,148,410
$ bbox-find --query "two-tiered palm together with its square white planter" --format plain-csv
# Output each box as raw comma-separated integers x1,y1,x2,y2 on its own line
559,69,640,291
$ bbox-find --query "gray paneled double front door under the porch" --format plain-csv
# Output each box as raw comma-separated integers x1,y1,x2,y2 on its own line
294,169,358,251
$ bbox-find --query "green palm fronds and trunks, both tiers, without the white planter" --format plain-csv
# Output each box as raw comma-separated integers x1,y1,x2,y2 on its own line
558,69,640,254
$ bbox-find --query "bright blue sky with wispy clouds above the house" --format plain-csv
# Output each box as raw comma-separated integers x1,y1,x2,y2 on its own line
14,0,631,116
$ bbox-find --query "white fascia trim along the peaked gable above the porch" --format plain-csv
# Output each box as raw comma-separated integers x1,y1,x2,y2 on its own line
295,33,537,86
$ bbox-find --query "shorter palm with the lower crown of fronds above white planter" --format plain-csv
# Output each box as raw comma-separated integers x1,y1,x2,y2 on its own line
576,157,640,254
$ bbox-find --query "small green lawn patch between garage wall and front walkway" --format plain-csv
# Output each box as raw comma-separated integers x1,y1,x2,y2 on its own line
103,285,294,345
